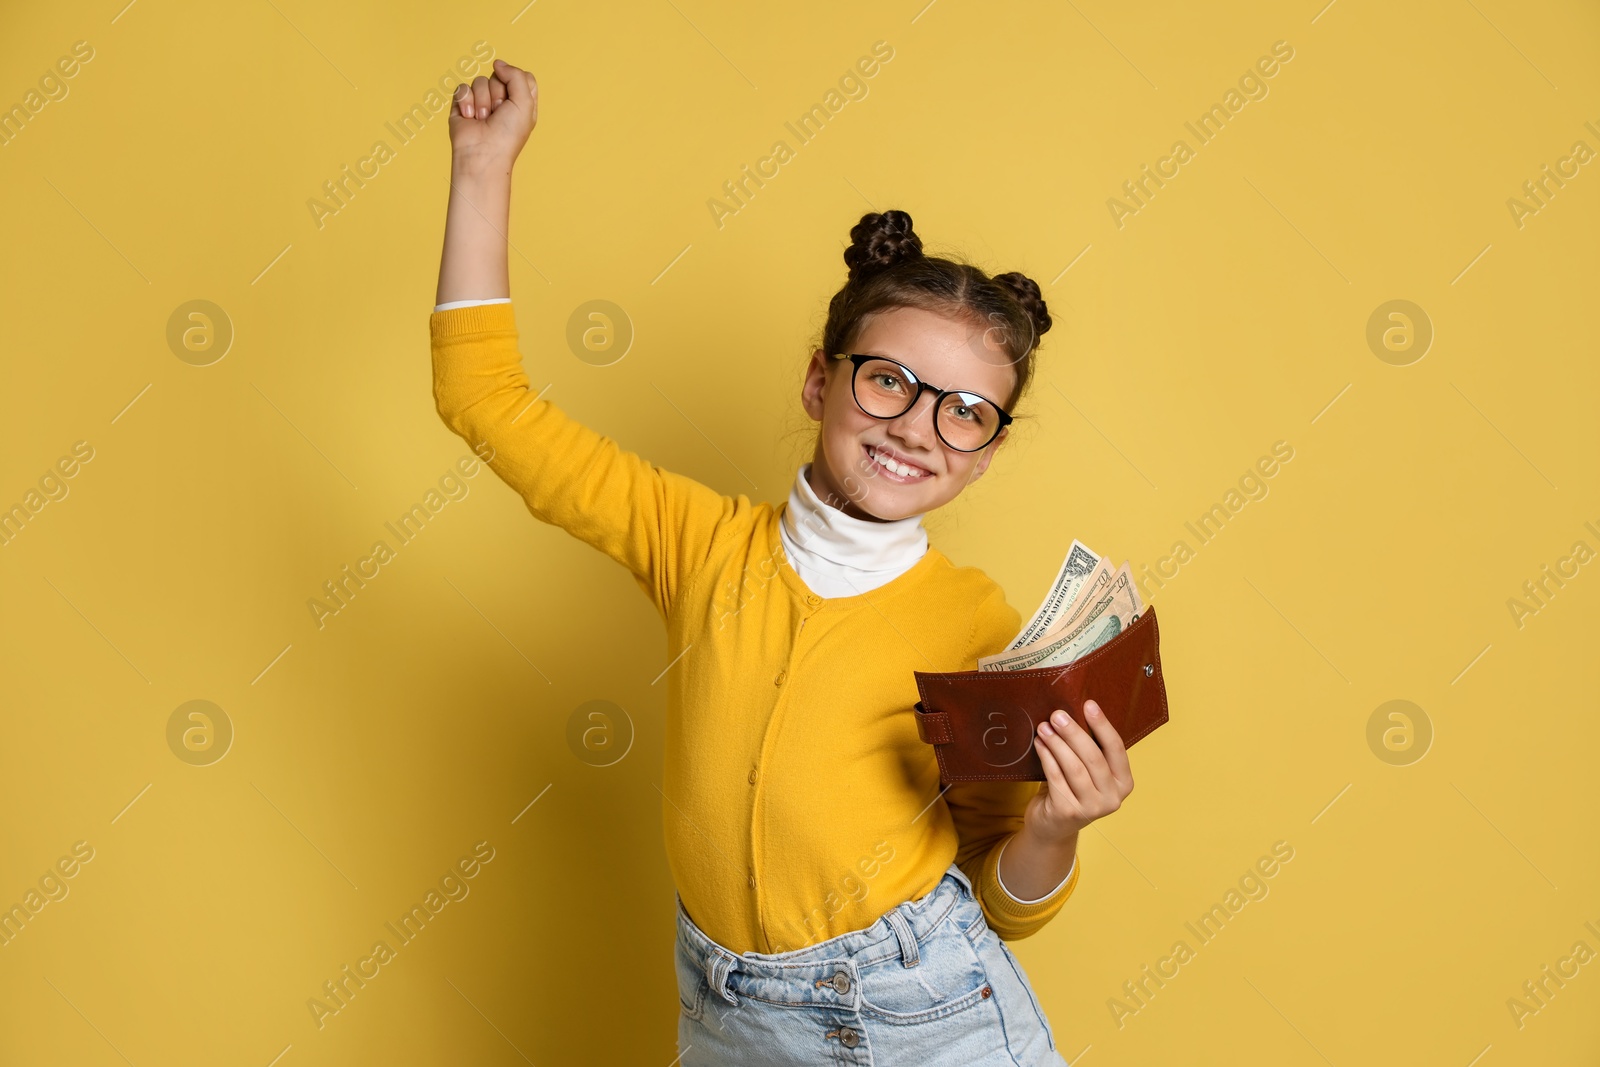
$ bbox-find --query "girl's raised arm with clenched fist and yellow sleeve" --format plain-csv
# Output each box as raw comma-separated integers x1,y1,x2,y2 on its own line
429,59,749,617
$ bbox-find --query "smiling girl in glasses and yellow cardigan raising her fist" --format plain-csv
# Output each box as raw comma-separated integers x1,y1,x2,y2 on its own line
429,59,1133,1067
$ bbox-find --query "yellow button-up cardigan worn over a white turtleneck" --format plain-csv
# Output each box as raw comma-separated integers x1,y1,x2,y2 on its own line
429,304,1083,953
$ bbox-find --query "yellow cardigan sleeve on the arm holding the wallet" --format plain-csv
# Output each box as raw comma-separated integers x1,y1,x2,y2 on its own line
944,585,1083,941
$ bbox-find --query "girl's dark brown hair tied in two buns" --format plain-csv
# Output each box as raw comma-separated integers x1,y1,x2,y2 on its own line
821,208,1050,414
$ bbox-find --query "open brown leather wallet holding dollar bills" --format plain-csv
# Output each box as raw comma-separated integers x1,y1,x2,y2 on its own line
914,606,1166,785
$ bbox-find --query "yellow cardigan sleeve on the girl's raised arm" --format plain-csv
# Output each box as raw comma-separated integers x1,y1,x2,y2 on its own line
429,302,744,617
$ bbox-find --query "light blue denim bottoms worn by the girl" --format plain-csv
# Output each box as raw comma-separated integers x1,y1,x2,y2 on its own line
675,864,1066,1067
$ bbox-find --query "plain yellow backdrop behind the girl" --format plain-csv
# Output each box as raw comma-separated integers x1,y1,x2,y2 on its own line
0,0,1600,1067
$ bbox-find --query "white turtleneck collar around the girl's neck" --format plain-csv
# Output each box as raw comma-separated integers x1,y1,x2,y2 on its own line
779,462,928,597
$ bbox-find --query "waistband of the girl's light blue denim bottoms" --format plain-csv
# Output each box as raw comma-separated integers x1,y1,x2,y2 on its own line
677,864,978,1009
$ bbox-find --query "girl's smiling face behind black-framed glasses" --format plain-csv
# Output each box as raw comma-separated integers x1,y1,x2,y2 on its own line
800,307,1016,522
